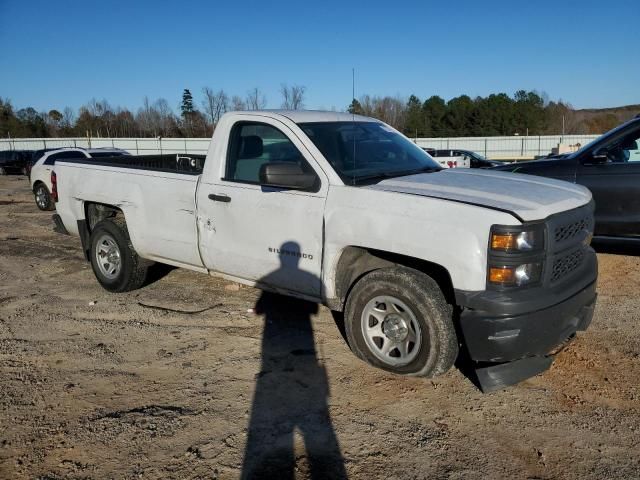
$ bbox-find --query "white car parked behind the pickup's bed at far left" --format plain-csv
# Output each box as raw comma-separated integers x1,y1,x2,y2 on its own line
30,148,129,210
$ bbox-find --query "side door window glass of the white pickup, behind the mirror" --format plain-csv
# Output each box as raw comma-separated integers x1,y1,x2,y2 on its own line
225,122,311,184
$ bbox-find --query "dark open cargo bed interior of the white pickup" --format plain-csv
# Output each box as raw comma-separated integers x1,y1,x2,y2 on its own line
64,153,206,175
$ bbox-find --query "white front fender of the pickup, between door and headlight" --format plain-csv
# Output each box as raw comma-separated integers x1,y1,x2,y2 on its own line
323,187,521,298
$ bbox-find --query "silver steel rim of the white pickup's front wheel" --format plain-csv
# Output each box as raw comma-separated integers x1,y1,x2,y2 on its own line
361,295,422,367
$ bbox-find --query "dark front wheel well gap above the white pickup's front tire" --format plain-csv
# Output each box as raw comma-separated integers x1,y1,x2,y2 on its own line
327,246,455,311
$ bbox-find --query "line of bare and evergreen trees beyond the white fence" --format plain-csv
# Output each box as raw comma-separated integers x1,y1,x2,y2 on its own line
0,84,626,138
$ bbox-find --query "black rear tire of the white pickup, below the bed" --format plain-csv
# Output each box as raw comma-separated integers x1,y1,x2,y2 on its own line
89,216,152,292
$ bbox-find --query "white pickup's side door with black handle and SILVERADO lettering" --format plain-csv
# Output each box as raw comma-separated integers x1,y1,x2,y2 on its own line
198,117,328,299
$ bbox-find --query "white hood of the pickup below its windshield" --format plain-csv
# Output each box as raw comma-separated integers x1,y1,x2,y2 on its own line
364,168,591,221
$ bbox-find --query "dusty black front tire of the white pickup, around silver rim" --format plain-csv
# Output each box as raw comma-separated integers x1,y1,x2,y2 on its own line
345,266,458,377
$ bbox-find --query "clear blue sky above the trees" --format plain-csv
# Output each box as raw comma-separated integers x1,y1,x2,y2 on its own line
0,0,640,110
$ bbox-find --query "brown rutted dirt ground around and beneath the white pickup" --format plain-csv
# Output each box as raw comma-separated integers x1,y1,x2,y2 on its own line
0,176,640,479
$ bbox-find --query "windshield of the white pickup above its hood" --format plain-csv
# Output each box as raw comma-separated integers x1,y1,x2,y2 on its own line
299,122,441,185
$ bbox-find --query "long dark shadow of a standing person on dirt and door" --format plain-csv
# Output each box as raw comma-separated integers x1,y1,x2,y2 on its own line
242,242,346,479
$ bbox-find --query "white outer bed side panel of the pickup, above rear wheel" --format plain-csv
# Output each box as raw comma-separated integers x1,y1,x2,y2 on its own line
56,163,203,268
